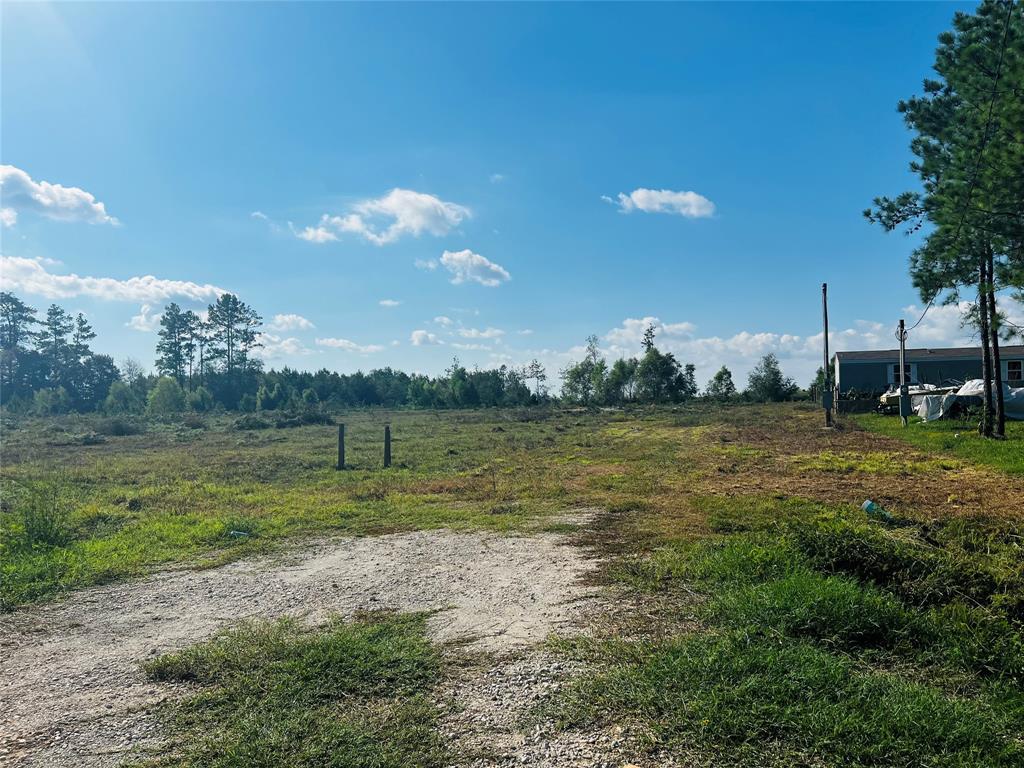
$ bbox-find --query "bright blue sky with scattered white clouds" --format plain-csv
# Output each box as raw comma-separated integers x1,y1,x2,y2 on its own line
0,2,1024,384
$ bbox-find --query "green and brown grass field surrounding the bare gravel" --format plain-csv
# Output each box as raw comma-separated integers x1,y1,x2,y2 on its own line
2,404,1024,766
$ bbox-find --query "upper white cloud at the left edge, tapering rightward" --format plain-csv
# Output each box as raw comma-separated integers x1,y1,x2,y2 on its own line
0,165,118,226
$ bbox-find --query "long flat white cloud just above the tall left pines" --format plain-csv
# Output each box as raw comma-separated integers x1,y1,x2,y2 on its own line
0,256,228,304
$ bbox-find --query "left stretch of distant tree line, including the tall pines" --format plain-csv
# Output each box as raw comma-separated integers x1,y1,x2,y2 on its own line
0,292,552,415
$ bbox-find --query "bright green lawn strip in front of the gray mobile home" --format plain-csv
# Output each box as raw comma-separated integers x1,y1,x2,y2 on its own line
849,414,1024,475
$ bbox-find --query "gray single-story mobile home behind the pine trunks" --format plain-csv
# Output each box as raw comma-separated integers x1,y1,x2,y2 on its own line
835,346,1024,395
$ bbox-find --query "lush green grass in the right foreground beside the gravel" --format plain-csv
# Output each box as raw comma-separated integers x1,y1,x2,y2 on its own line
549,497,1024,766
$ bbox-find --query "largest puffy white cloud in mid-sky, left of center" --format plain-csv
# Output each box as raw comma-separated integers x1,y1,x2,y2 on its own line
296,188,471,246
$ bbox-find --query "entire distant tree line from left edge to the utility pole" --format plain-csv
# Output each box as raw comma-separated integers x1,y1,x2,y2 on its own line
0,292,799,415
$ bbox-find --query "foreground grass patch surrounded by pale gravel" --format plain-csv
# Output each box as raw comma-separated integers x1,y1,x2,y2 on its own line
134,614,446,768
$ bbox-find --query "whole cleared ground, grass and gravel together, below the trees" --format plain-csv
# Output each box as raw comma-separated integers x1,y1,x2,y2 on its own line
0,406,1024,766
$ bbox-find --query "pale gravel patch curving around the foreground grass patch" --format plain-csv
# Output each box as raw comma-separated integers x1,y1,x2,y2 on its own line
0,530,595,768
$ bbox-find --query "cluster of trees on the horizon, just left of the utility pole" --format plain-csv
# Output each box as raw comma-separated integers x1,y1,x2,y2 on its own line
561,326,801,406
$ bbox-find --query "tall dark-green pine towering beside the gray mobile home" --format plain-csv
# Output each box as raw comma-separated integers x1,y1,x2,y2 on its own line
864,0,1024,435
